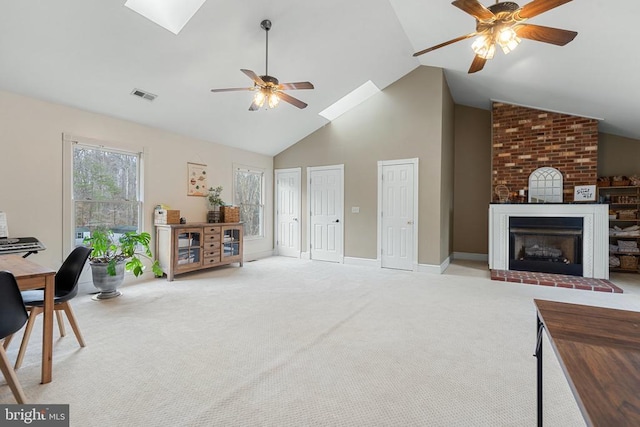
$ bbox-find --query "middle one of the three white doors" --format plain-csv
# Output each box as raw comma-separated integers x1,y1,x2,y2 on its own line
307,165,344,262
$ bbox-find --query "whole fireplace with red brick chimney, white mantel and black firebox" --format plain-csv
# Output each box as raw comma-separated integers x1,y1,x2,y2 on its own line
489,102,609,279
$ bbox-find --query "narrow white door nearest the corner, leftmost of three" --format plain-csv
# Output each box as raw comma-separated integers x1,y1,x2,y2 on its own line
276,168,301,258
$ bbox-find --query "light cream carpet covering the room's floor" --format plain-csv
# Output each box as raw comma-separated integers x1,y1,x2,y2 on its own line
0,257,640,427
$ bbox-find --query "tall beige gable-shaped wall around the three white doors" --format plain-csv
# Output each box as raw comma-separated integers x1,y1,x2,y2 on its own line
274,67,453,265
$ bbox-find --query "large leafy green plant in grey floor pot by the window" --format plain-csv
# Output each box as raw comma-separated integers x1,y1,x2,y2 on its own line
84,228,163,299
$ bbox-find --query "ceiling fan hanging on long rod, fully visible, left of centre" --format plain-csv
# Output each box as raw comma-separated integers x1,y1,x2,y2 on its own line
211,19,313,111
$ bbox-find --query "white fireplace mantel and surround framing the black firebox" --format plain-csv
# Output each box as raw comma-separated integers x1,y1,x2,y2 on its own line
489,203,609,279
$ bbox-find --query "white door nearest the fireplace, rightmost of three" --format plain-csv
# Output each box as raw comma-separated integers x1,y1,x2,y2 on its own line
380,160,417,270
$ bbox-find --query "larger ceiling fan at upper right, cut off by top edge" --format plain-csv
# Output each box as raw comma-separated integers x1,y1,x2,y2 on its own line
413,0,578,73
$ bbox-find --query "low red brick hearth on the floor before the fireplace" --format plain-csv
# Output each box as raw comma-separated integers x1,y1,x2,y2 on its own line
491,270,622,294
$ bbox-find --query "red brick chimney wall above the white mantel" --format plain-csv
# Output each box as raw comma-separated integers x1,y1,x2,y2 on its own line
492,102,598,202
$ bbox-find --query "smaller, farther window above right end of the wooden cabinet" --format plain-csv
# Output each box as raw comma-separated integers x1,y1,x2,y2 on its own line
233,167,264,239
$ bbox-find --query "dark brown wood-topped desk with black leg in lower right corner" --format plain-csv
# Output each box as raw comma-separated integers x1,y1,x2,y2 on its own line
534,300,640,427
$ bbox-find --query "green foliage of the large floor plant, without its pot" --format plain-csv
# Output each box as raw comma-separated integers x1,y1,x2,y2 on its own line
84,228,163,277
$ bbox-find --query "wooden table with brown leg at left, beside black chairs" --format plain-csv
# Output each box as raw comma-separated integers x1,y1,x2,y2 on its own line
0,255,56,384
